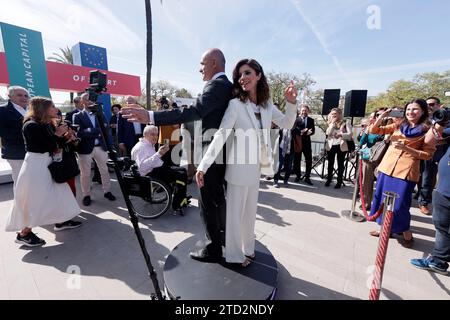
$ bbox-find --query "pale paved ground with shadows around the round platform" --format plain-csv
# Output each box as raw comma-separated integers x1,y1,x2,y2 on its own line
0,172,450,300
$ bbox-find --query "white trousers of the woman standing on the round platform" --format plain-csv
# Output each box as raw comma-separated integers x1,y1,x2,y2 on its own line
225,183,259,263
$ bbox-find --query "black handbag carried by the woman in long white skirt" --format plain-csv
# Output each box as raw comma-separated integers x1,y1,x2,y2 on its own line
48,146,80,183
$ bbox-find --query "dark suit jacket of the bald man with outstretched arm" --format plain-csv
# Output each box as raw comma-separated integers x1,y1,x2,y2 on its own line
154,75,233,133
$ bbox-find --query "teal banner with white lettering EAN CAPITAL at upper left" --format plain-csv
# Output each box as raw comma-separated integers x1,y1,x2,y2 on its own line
0,22,50,98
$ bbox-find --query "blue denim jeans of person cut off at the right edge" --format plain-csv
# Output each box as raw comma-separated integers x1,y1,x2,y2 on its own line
432,191,450,262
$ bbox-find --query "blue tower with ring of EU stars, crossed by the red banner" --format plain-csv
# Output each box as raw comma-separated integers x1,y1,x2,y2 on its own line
72,42,111,120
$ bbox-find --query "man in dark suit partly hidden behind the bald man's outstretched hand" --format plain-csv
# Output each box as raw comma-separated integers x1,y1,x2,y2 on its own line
117,96,145,156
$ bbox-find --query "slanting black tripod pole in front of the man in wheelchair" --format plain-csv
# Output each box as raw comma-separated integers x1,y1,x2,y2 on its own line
89,99,165,300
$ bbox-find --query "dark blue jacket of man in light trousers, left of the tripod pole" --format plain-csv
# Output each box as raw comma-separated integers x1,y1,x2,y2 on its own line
73,110,108,154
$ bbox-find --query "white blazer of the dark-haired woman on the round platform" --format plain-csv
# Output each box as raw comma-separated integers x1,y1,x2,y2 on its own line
197,98,297,186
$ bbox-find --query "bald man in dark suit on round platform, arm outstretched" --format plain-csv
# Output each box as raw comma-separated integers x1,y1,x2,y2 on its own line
122,49,233,262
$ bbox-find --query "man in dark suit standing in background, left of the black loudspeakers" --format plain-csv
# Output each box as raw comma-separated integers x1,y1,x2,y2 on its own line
294,105,316,186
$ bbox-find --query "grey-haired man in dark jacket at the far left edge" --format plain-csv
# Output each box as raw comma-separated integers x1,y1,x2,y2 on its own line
0,86,30,189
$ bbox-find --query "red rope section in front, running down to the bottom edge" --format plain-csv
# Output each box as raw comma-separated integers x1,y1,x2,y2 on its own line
369,210,394,300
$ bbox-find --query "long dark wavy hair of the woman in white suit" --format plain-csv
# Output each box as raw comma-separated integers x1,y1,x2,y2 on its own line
233,59,270,107
